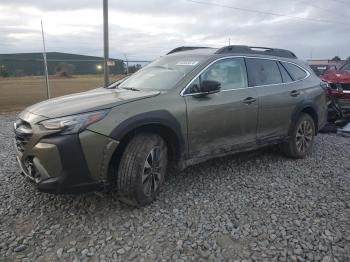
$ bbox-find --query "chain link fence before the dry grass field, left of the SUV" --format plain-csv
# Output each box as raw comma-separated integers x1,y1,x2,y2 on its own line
0,52,150,111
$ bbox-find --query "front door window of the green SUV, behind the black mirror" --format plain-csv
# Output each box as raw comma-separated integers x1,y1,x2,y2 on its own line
186,57,248,94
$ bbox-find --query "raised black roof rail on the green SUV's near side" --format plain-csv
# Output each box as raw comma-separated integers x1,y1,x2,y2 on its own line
215,45,297,58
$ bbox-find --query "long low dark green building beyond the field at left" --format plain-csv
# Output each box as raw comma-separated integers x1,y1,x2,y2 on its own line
0,52,125,76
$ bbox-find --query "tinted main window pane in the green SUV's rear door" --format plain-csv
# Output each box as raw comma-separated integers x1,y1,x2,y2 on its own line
246,58,282,86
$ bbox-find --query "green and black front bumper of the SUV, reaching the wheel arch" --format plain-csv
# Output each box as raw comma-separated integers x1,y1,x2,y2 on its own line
15,115,118,193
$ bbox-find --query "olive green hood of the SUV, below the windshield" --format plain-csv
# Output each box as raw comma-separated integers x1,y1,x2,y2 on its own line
26,88,160,118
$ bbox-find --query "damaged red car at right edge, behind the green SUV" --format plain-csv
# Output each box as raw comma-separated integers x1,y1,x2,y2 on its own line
321,62,350,118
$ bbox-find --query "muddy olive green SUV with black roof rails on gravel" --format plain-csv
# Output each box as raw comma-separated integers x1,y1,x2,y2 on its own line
14,46,327,206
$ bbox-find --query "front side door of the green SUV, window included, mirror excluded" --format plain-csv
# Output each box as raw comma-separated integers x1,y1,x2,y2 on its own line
184,58,258,158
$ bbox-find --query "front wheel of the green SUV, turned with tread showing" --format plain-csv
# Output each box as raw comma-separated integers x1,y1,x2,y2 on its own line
117,133,168,206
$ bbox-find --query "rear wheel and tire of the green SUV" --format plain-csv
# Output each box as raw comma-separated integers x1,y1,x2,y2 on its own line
282,113,315,158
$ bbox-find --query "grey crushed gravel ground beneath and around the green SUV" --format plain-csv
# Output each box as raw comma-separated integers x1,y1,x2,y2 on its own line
0,114,350,262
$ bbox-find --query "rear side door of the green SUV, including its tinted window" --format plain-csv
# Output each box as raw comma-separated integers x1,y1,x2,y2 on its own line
246,58,300,142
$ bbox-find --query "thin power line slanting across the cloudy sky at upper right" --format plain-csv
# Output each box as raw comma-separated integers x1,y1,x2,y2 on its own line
186,0,350,26
